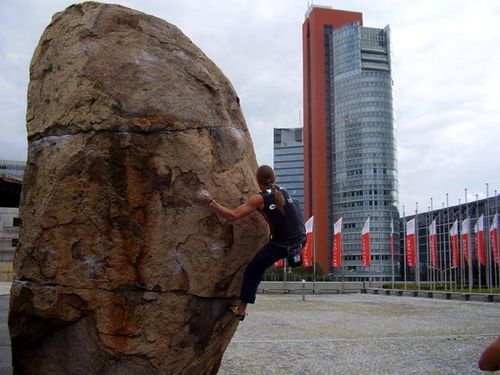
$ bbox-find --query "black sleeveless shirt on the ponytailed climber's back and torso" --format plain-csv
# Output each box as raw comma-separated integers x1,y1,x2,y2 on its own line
260,186,306,244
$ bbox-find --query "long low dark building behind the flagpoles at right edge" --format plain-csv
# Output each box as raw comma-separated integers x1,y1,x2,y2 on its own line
396,195,500,289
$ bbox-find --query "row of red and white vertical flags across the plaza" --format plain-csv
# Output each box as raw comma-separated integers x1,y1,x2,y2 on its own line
275,214,500,268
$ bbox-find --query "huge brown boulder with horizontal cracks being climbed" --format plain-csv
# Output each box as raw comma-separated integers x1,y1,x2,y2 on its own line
9,2,267,375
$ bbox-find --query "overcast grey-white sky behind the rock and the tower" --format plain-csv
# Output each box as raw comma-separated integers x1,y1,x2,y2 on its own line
0,0,500,214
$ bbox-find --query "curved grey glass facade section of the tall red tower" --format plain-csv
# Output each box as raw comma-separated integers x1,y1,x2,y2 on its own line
327,24,399,280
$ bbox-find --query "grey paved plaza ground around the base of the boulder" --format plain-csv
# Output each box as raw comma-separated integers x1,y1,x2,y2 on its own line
0,285,500,375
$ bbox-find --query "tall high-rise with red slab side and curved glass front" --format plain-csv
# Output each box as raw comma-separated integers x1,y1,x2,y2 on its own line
303,6,399,280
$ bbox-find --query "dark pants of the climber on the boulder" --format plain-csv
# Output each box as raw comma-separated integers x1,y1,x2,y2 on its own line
240,241,287,303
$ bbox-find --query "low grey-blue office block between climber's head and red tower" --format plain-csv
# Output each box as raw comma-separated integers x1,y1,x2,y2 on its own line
274,128,304,210
